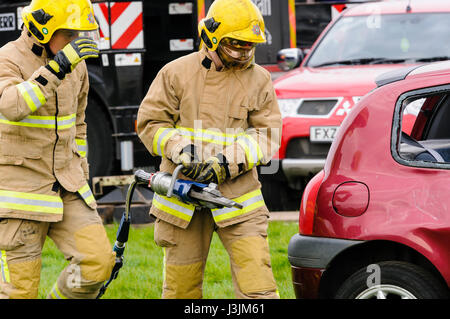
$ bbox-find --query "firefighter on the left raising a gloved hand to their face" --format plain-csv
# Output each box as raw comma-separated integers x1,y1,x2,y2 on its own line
0,0,114,298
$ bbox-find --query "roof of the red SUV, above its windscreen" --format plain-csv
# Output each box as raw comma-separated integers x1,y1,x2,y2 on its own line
342,0,450,16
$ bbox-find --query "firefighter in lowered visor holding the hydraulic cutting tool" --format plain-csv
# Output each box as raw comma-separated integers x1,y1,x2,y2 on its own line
137,0,281,298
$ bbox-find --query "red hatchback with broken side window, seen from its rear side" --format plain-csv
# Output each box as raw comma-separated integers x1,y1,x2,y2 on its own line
288,61,450,299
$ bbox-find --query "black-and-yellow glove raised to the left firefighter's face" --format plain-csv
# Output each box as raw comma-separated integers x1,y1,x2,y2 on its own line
47,37,99,80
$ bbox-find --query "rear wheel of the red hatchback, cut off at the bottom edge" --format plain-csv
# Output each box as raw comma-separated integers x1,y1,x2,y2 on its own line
335,261,449,299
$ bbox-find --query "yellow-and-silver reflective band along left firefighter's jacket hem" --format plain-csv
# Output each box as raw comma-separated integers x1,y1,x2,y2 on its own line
0,190,63,214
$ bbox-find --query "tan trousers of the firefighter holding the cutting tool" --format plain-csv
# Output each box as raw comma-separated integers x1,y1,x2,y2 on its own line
155,209,279,299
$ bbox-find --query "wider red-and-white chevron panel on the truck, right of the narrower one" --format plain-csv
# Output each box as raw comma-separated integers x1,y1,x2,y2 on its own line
110,1,144,49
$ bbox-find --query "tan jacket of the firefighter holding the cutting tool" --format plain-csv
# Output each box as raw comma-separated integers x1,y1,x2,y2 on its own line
137,50,282,228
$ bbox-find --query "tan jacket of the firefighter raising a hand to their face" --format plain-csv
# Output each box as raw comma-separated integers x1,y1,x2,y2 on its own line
0,29,96,222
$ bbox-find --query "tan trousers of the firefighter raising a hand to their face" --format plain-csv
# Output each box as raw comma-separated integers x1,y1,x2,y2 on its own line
0,190,114,299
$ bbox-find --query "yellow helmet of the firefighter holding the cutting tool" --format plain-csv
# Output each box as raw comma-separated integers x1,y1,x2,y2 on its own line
198,0,266,51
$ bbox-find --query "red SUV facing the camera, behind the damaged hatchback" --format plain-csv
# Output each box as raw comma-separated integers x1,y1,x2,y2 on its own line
261,0,450,210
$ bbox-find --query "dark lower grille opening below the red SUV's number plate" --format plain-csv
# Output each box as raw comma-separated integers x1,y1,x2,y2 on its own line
286,137,331,158
